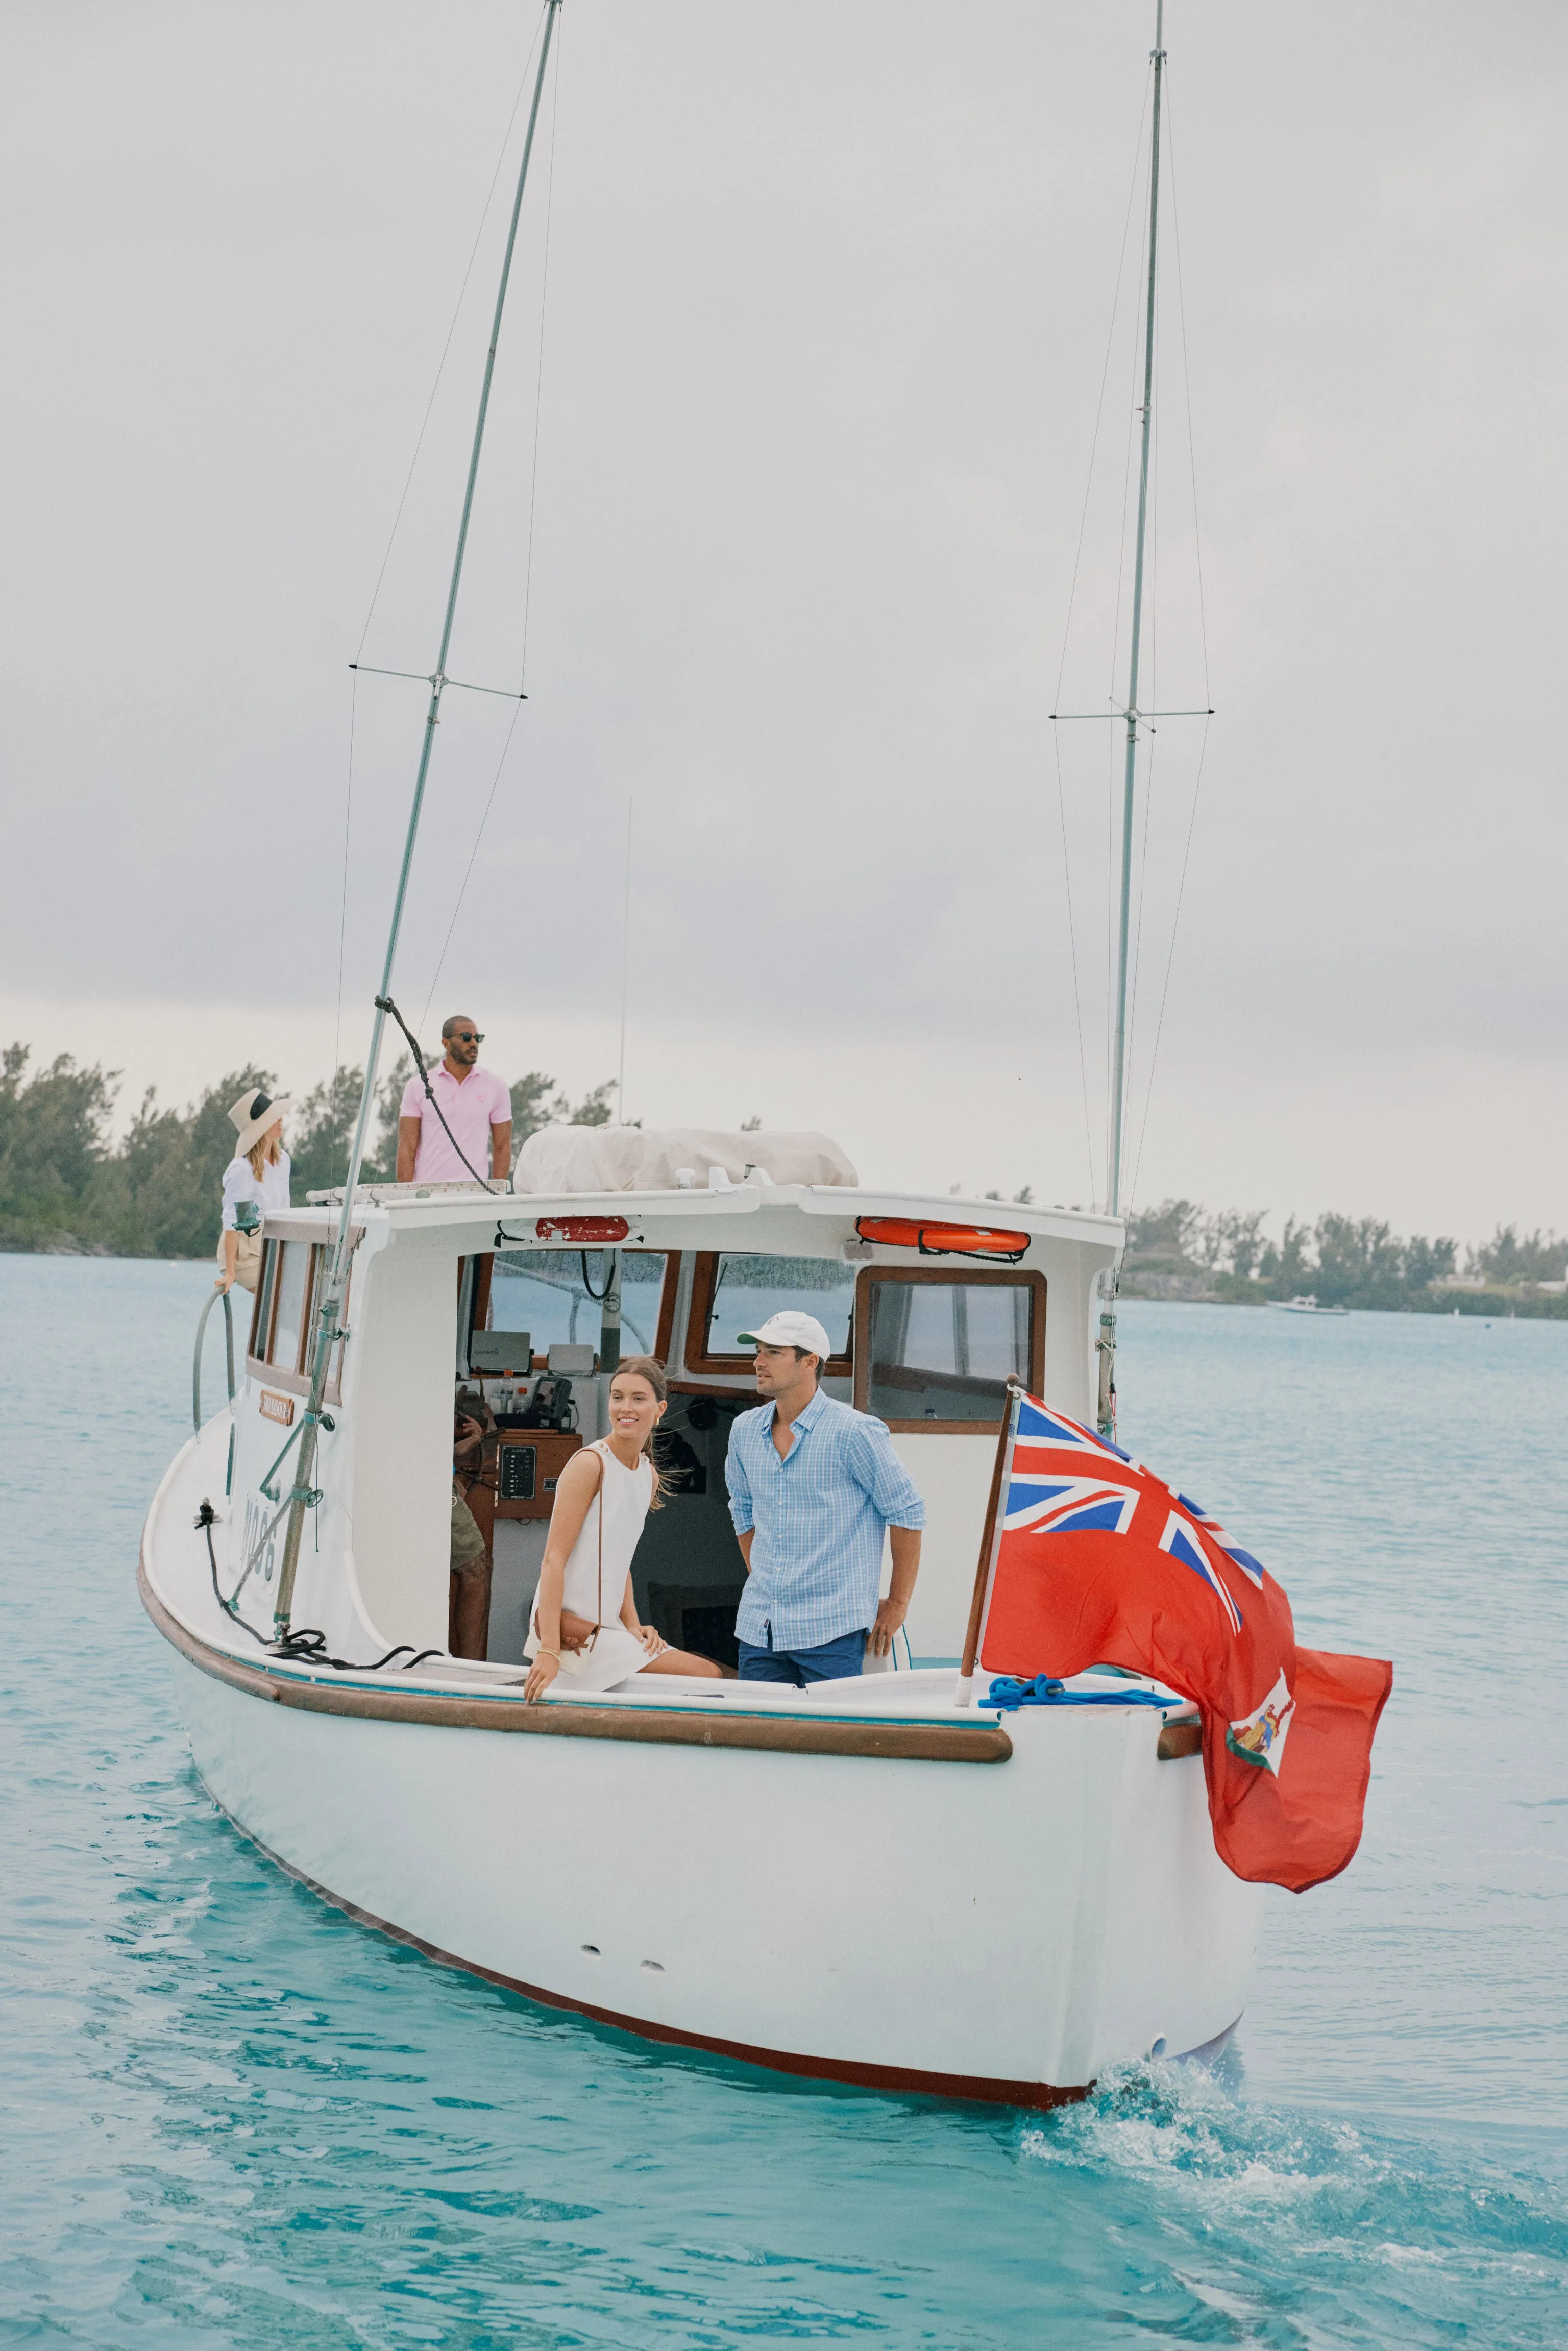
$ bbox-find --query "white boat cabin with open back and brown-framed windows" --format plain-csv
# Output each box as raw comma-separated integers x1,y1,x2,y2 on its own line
228,1136,1121,1664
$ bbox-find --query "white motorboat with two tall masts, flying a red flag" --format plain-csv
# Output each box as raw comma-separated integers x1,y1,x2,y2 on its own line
139,0,1258,2107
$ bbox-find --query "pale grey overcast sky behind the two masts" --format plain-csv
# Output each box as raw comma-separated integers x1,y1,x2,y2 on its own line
0,0,1568,1239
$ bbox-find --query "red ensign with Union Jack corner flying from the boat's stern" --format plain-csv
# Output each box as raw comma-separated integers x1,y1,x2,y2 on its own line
981,1397,1394,1893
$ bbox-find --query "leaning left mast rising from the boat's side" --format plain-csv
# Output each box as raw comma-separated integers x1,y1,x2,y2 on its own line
273,0,562,1641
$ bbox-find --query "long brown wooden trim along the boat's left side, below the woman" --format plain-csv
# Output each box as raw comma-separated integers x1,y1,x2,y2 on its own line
136,1554,1013,1764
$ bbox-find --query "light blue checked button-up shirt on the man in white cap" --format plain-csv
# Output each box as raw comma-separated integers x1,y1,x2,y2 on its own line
724,1387,926,1648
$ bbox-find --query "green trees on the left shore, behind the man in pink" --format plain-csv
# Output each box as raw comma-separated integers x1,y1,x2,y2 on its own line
0,1044,614,1258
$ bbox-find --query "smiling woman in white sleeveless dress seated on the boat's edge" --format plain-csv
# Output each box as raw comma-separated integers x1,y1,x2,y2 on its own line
522,1354,722,1700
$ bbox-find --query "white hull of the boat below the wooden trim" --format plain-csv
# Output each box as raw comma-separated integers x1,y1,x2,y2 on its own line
156,1589,1255,2104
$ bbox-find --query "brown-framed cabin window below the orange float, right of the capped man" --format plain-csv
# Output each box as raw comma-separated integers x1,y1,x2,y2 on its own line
855,1267,1046,1432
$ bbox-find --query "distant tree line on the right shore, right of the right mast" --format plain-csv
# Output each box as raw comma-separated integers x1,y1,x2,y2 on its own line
1121,1199,1568,1314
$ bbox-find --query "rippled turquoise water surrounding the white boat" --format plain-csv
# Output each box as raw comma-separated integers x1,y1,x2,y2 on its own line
0,1258,1568,2351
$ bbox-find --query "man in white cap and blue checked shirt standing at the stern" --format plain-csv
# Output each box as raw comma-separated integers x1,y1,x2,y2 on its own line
724,1312,926,1688
